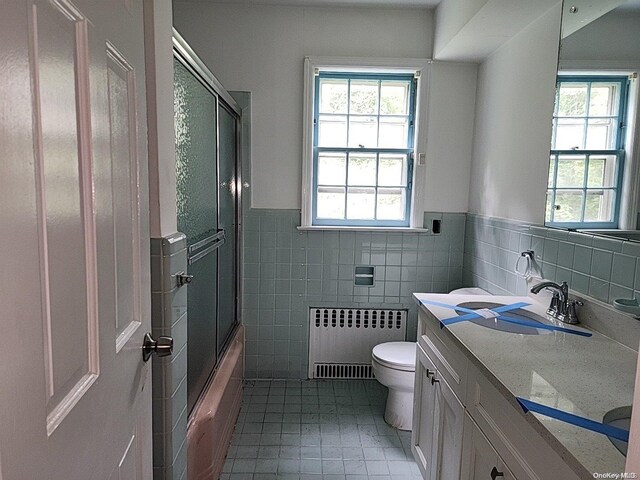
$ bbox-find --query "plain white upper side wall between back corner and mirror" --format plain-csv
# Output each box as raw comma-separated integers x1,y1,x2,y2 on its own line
469,4,561,223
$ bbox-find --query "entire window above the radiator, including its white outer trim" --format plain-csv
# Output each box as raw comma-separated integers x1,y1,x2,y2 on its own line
301,57,429,230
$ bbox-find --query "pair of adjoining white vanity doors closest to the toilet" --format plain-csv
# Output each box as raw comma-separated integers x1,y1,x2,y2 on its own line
413,346,464,480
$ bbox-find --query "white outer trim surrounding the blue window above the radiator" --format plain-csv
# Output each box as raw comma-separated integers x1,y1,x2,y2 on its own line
299,57,431,231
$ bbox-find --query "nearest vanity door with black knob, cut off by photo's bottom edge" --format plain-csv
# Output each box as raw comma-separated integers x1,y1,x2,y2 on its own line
460,414,515,480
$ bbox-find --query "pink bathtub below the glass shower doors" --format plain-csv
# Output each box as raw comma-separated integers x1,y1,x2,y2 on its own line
187,326,244,480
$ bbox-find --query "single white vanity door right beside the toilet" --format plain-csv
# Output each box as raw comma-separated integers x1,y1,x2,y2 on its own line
411,346,438,480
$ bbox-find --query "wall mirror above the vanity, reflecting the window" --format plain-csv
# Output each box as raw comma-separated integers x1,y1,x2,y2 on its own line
545,0,640,242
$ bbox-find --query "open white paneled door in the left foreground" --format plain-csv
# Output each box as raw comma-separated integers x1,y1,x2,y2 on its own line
0,0,151,480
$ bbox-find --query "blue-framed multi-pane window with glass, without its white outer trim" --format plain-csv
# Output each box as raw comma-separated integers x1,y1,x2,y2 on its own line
313,72,416,226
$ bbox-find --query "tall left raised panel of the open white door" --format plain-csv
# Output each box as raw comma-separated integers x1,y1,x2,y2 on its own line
31,3,99,426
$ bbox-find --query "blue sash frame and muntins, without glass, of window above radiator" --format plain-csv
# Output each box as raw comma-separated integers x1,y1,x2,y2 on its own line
312,72,416,227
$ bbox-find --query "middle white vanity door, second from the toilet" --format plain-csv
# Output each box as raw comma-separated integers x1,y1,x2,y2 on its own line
432,373,464,480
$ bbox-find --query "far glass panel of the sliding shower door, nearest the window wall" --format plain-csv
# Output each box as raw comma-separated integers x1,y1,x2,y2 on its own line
218,107,238,355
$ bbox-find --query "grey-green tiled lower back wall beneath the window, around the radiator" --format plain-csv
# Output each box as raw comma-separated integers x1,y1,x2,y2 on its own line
242,209,465,379
